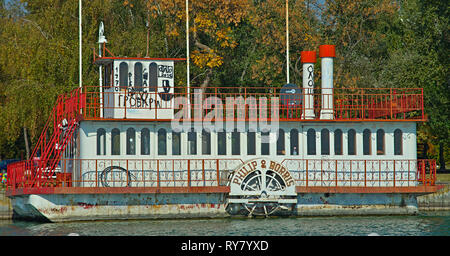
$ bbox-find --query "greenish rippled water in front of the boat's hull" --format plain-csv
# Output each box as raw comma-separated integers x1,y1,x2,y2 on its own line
0,211,450,236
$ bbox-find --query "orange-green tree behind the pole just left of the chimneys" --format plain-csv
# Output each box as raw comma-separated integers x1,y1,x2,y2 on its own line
250,0,321,86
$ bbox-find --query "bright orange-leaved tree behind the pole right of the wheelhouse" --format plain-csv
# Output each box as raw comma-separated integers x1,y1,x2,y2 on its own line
147,0,249,88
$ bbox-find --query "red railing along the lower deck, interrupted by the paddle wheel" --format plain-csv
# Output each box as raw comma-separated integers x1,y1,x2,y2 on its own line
8,159,436,194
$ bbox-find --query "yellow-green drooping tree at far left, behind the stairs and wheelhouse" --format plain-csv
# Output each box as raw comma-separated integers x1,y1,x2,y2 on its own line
0,0,153,158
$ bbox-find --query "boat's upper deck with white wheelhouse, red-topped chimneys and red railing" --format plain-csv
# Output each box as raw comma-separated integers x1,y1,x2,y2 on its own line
84,41,426,122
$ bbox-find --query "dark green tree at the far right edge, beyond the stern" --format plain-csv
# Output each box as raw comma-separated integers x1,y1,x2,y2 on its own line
380,0,450,170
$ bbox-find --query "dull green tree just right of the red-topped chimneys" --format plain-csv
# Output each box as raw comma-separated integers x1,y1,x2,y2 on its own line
319,0,398,88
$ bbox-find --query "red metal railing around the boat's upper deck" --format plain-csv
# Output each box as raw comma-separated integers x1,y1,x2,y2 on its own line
79,86,426,121
